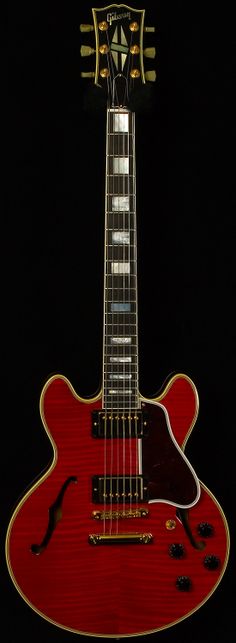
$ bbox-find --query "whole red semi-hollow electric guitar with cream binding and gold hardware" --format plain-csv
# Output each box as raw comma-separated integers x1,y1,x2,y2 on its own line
6,4,229,638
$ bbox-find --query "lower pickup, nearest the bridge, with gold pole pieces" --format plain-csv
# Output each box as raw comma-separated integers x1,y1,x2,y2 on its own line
92,475,148,504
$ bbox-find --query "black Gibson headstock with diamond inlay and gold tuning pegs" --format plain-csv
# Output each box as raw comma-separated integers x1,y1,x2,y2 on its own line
80,4,156,107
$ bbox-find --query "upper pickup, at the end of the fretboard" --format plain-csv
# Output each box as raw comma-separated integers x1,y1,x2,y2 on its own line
92,410,148,438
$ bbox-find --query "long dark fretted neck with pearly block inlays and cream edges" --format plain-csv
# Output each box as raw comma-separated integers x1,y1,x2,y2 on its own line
103,108,139,409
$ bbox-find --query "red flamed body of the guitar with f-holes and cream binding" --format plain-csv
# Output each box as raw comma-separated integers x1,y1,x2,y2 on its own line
6,375,229,637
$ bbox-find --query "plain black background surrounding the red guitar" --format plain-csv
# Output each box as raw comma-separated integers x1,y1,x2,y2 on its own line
1,0,236,643
